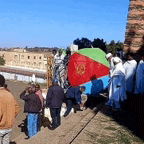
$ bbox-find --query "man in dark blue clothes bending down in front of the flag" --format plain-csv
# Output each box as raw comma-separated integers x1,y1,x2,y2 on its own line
64,86,86,117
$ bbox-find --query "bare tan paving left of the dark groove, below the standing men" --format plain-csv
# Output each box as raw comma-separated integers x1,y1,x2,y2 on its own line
13,110,93,144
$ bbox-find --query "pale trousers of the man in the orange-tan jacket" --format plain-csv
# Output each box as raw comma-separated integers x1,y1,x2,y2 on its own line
0,129,12,144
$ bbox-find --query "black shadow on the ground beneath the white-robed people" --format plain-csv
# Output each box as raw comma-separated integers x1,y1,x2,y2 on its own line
85,95,144,140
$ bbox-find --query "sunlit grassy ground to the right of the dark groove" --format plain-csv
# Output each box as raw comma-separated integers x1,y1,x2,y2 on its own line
72,112,144,144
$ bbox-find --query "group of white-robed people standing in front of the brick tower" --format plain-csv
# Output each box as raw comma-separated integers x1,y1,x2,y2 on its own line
106,52,144,110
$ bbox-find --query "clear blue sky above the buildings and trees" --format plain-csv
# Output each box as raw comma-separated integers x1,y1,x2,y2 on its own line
0,0,129,47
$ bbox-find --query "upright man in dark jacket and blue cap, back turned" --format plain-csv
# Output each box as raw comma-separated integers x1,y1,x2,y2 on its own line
46,79,64,130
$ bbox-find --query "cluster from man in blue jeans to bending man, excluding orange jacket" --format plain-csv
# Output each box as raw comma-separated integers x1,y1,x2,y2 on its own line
20,78,85,138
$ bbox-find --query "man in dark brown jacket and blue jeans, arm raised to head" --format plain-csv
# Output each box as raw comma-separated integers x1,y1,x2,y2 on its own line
20,87,42,138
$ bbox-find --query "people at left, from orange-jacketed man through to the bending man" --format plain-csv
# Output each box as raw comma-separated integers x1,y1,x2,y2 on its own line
0,75,85,144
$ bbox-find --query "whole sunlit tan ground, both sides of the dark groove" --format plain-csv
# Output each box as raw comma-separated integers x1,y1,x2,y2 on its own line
7,81,144,144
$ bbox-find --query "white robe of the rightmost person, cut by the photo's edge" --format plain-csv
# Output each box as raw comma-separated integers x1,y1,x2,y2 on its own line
134,60,144,94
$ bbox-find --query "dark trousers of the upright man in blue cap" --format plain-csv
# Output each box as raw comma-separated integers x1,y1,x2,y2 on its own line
50,108,61,128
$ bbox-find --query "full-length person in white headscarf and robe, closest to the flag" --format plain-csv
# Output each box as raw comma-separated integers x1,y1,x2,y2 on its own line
106,57,126,109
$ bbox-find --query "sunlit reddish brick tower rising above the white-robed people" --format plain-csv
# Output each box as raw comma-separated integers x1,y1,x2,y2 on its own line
124,0,144,52
